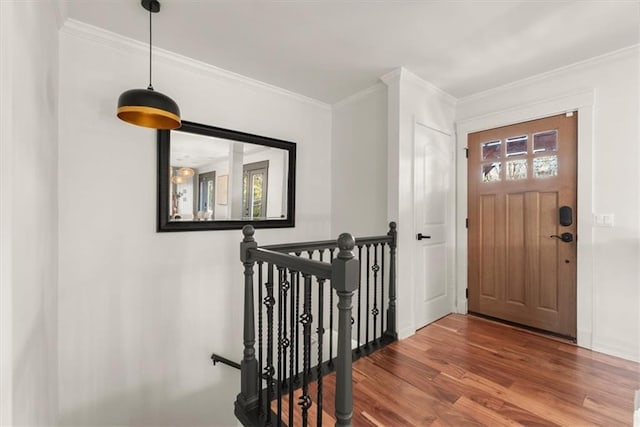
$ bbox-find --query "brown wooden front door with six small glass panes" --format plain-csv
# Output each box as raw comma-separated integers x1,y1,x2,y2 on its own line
468,113,577,337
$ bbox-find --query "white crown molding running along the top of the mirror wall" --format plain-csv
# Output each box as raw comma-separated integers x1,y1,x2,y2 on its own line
60,19,331,110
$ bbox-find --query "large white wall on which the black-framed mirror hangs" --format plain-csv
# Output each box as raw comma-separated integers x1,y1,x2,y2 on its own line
58,22,332,426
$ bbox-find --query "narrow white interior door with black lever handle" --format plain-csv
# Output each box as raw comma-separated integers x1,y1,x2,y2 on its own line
414,124,454,328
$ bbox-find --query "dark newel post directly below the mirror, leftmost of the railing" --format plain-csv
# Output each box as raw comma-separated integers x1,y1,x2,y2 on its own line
236,225,259,414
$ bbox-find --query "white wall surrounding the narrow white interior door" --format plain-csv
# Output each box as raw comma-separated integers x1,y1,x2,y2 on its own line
381,68,455,338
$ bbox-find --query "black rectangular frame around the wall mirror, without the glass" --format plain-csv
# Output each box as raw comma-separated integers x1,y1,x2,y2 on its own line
157,120,296,232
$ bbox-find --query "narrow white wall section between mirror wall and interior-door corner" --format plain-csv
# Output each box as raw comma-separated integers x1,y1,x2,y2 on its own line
332,83,388,237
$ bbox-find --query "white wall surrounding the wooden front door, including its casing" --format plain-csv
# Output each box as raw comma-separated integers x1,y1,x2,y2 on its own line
456,47,640,361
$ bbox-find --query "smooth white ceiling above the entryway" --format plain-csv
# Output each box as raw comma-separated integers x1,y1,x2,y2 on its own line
65,0,640,104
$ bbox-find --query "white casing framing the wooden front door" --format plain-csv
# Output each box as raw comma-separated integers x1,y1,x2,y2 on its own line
455,91,595,348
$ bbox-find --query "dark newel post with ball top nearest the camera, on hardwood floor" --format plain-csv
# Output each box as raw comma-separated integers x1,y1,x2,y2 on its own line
331,233,360,426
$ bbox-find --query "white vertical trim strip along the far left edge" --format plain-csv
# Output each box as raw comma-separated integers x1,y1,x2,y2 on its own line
0,1,14,426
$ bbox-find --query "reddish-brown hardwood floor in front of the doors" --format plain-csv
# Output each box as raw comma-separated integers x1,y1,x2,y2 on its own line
282,315,640,426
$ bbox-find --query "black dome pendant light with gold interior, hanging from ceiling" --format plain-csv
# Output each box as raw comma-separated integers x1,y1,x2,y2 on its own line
117,0,180,129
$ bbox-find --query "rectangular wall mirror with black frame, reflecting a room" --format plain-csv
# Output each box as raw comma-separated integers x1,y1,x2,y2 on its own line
158,121,296,231
